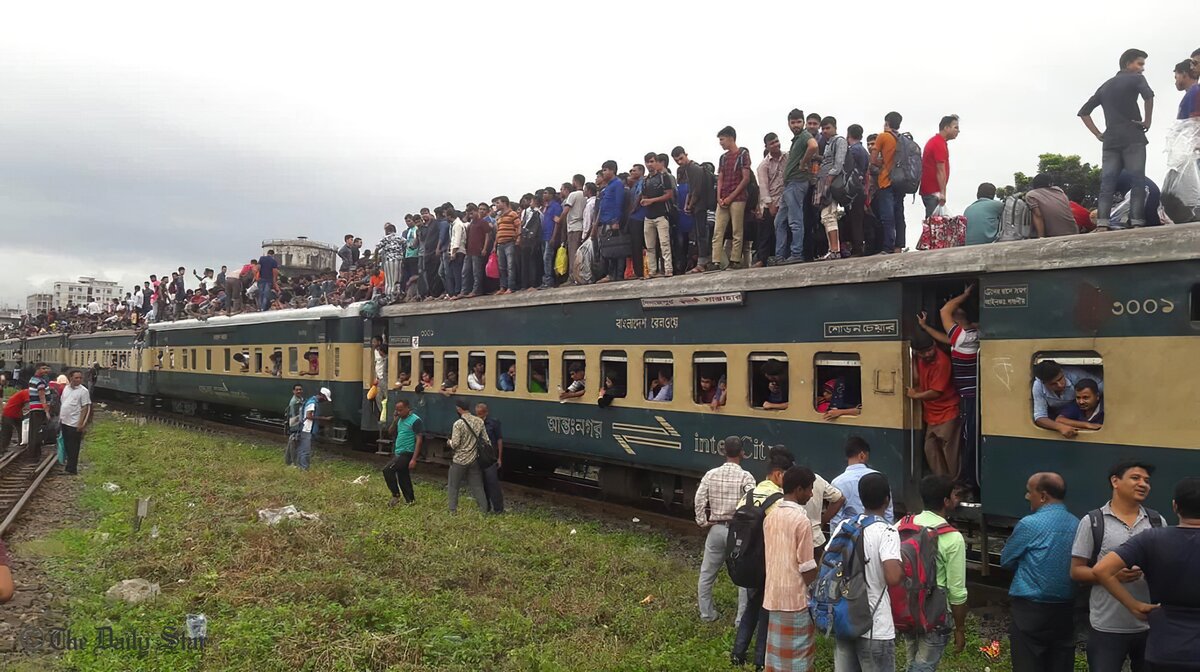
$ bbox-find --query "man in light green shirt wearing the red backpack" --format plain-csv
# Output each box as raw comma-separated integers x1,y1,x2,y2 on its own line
892,474,967,672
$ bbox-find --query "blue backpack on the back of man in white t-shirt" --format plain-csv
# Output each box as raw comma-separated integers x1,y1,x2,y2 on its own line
809,515,887,640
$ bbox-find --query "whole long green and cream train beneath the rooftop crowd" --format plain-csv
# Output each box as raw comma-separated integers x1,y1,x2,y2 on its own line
0,224,1200,526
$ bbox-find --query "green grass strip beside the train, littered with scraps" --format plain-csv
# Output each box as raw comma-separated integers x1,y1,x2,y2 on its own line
18,420,1046,672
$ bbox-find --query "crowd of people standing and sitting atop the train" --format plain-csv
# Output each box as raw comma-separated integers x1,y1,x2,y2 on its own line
9,49,1200,337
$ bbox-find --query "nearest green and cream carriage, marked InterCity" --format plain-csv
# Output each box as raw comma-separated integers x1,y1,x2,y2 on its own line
376,226,1200,517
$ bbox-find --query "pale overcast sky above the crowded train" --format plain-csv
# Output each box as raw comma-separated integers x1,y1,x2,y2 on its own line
0,0,1200,306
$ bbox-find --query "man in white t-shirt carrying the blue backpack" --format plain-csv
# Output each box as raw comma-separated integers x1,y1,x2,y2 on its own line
833,472,904,672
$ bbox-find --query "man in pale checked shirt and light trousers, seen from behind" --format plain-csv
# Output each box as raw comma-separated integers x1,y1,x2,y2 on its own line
696,437,755,622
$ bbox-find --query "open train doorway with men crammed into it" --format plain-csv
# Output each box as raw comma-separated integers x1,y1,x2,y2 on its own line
901,276,986,500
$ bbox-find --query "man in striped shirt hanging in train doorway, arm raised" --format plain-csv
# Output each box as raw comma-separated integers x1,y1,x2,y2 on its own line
919,284,979,491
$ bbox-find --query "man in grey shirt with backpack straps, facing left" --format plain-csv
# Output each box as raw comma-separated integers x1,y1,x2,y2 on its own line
1070,461,1166,672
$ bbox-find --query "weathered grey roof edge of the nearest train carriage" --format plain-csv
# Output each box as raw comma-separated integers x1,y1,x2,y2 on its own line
380,224,1200,317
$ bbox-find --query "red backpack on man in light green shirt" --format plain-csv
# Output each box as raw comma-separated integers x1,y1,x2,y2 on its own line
888,516,958,636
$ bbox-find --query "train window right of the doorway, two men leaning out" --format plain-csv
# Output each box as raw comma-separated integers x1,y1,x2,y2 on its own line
1031,350,1104,431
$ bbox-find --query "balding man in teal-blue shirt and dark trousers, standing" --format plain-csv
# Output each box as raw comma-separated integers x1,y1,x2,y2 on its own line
1000,472,1079,672
